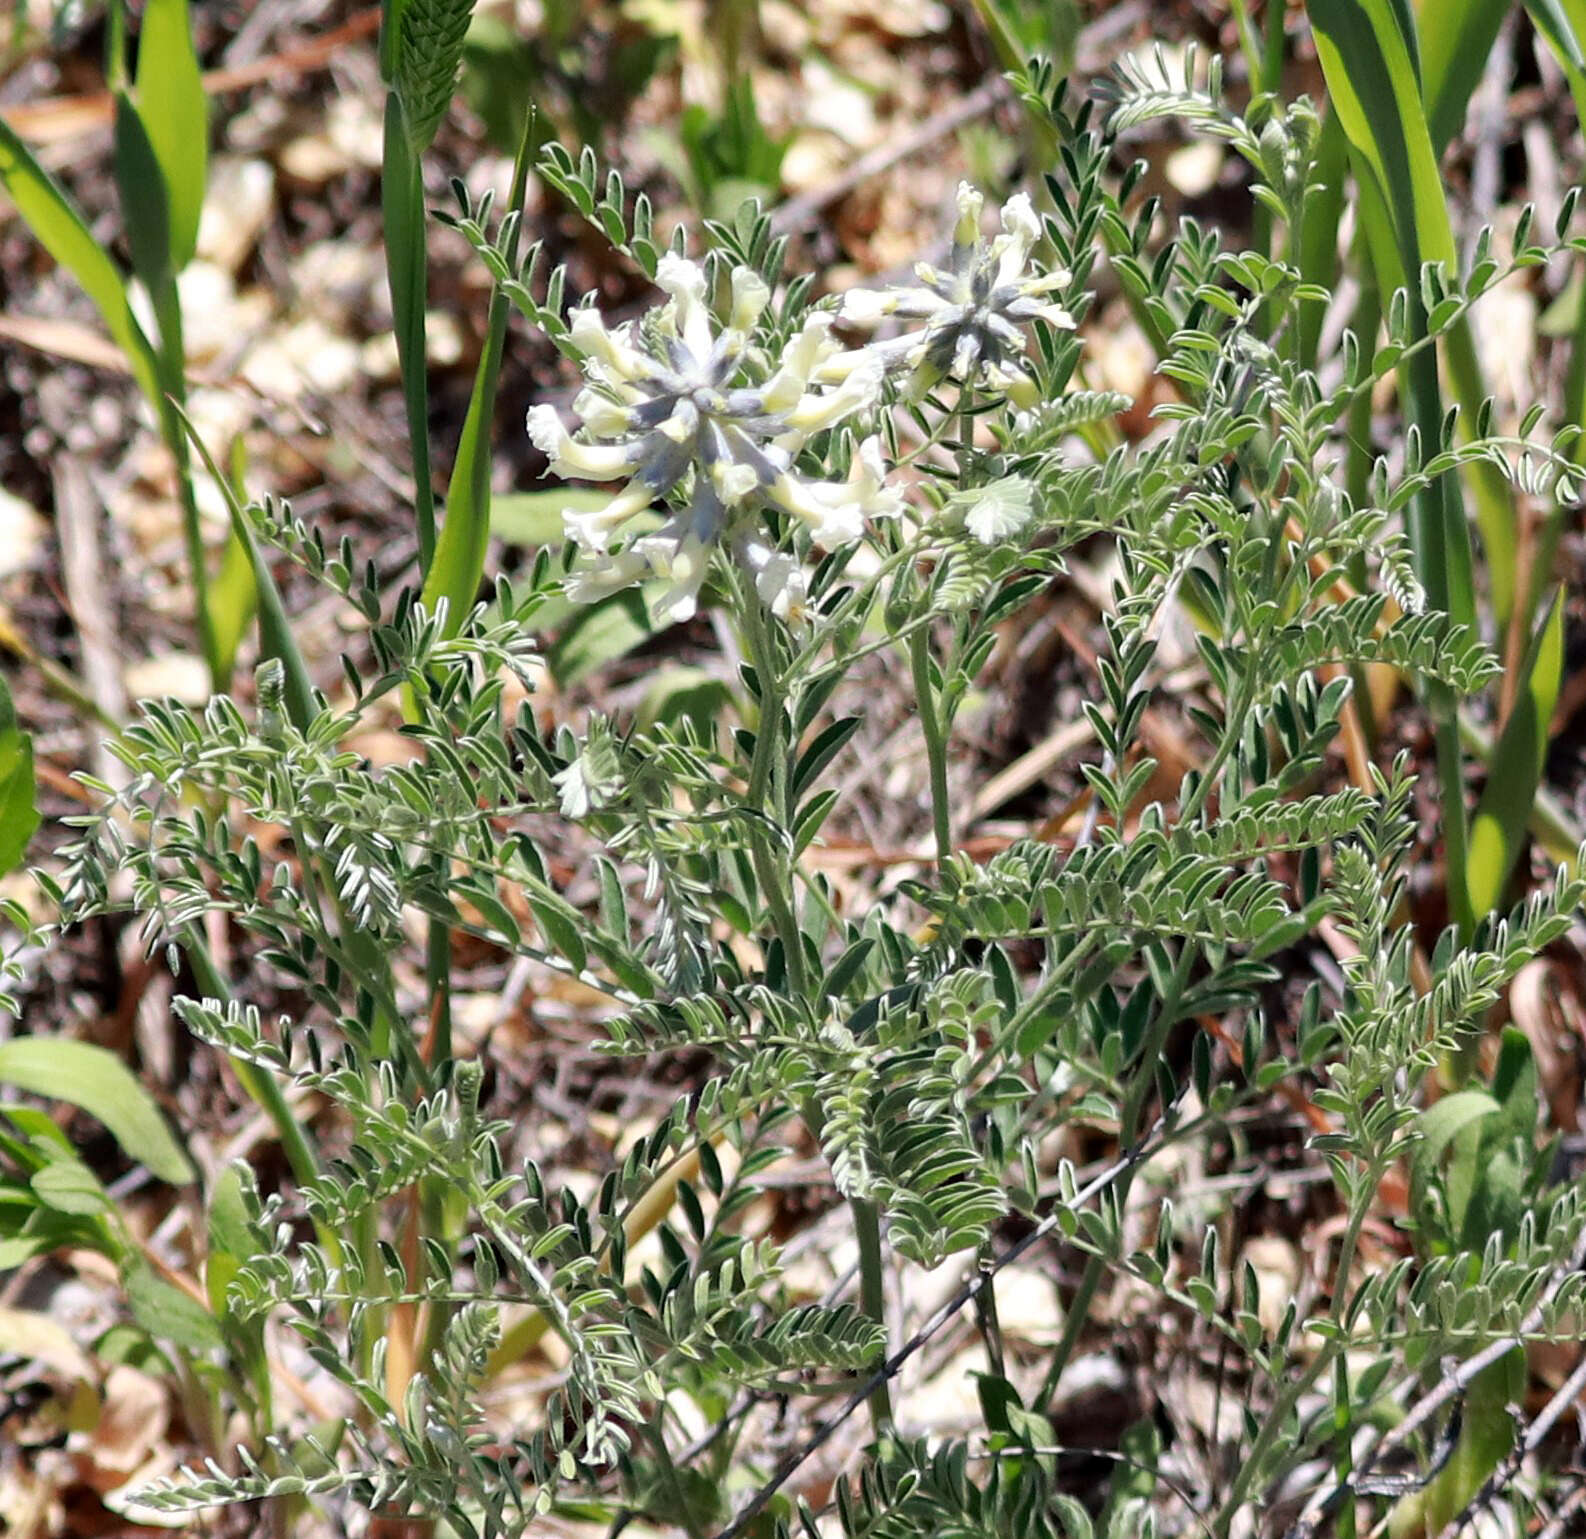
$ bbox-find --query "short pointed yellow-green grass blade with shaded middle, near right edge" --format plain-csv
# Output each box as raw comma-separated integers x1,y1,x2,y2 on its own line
1465,593,1564,914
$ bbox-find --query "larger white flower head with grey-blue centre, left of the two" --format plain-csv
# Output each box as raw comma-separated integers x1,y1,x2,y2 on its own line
528,254,901,620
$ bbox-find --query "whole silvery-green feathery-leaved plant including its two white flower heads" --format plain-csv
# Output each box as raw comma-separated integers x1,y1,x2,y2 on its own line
21,53,1583,1539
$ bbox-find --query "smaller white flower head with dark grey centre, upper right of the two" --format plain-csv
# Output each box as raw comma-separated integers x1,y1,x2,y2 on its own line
839,182,1074,408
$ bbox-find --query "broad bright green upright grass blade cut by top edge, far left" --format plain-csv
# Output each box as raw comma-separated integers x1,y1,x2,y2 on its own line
138,0,209,271
